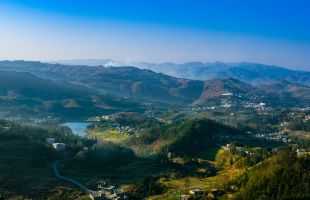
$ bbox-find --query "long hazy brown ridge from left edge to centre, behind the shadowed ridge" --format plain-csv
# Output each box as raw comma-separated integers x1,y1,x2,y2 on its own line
0,61,203,104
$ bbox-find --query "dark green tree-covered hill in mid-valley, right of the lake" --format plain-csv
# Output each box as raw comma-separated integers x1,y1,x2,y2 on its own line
129,119,244,157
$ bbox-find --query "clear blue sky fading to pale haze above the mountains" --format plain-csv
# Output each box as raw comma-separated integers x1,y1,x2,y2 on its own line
0,0,310,71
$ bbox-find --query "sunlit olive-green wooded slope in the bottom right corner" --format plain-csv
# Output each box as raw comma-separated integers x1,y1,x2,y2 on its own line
235,150,310,199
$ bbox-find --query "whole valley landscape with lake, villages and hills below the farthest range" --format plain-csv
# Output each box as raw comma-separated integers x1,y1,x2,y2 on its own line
0,61,310,200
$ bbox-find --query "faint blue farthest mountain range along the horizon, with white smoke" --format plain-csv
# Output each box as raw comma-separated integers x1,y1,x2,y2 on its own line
50,59,310,86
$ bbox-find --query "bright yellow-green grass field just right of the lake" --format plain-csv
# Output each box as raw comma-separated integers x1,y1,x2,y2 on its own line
87,129,130,143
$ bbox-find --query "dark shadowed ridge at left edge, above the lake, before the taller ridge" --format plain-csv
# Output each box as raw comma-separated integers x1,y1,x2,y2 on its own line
0,71,145,119
